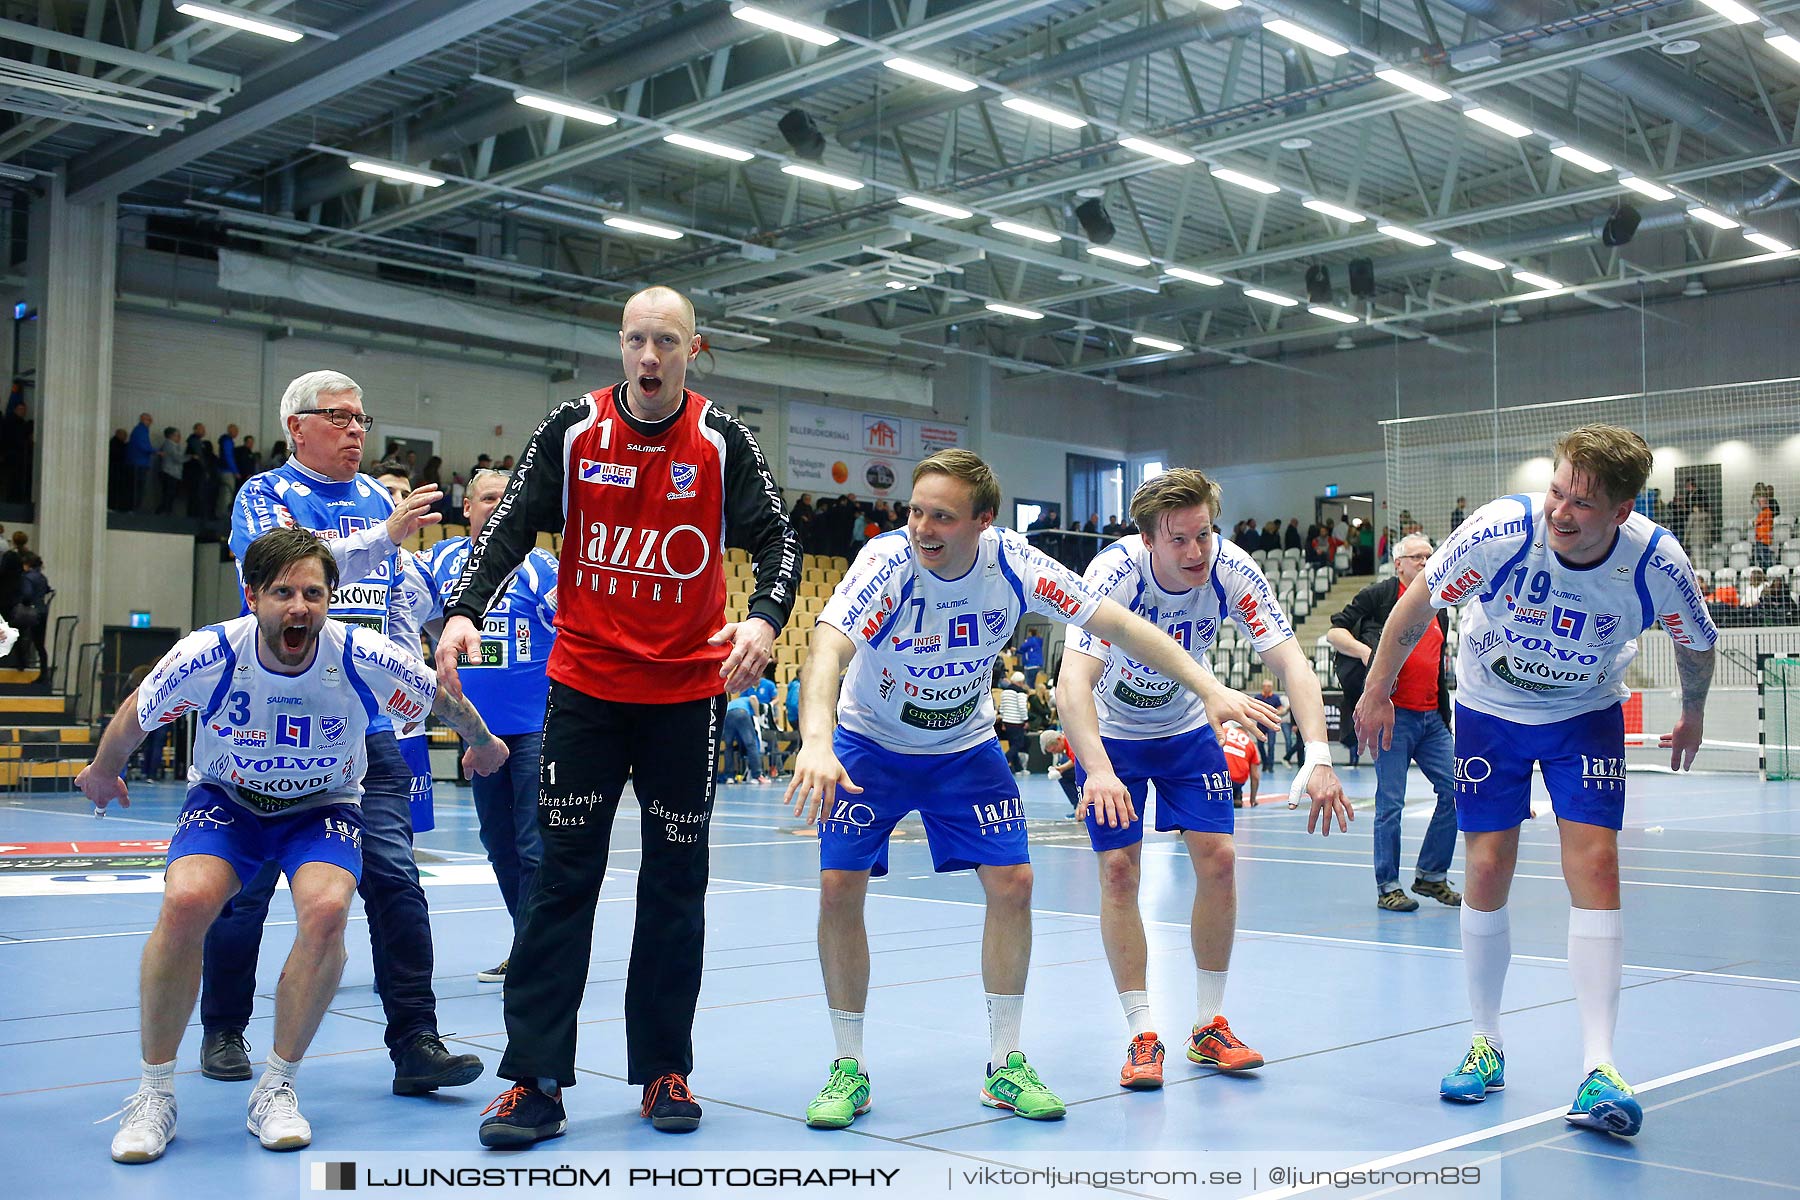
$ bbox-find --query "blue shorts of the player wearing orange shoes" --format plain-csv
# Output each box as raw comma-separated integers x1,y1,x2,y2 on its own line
1075,725,1237,851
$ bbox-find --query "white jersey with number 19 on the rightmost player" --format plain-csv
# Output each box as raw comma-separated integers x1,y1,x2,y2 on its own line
1424,491,1719,725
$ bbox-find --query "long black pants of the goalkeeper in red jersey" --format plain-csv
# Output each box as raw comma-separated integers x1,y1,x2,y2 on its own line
499,680,725,1087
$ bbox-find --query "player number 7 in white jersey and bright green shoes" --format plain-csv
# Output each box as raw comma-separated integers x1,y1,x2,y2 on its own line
787,450,1278,1130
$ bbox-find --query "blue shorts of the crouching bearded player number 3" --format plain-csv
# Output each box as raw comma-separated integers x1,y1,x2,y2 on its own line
164,783,362,883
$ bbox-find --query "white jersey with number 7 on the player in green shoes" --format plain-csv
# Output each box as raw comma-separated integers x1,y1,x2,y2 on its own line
819,529,1100,754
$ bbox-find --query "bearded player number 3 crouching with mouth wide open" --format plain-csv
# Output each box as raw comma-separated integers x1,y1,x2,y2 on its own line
76,529,506,1162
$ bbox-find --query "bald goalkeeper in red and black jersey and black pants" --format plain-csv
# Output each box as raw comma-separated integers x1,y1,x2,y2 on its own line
437,288,801,1146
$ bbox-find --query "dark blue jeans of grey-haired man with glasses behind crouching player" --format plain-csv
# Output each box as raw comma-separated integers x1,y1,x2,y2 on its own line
200,730,437,1060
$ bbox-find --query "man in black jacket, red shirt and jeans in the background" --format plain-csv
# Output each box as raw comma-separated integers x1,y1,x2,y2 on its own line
1325,533,1462,912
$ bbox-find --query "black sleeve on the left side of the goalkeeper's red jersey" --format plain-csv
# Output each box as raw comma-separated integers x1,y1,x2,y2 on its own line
445,396,594,624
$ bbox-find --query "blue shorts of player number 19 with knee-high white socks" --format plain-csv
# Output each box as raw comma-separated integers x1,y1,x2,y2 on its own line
1456,703,1625,833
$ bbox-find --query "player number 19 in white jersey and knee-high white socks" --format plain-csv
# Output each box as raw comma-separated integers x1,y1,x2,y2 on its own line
1355,425,1717,1137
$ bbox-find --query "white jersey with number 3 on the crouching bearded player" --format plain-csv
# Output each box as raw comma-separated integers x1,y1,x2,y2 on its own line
137,615,437,815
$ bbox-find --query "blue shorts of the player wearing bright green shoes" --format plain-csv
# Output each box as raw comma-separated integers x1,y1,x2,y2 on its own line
819,729,1031,876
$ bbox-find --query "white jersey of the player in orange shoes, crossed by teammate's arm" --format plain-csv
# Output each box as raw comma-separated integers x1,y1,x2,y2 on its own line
1071,534,1294,741
